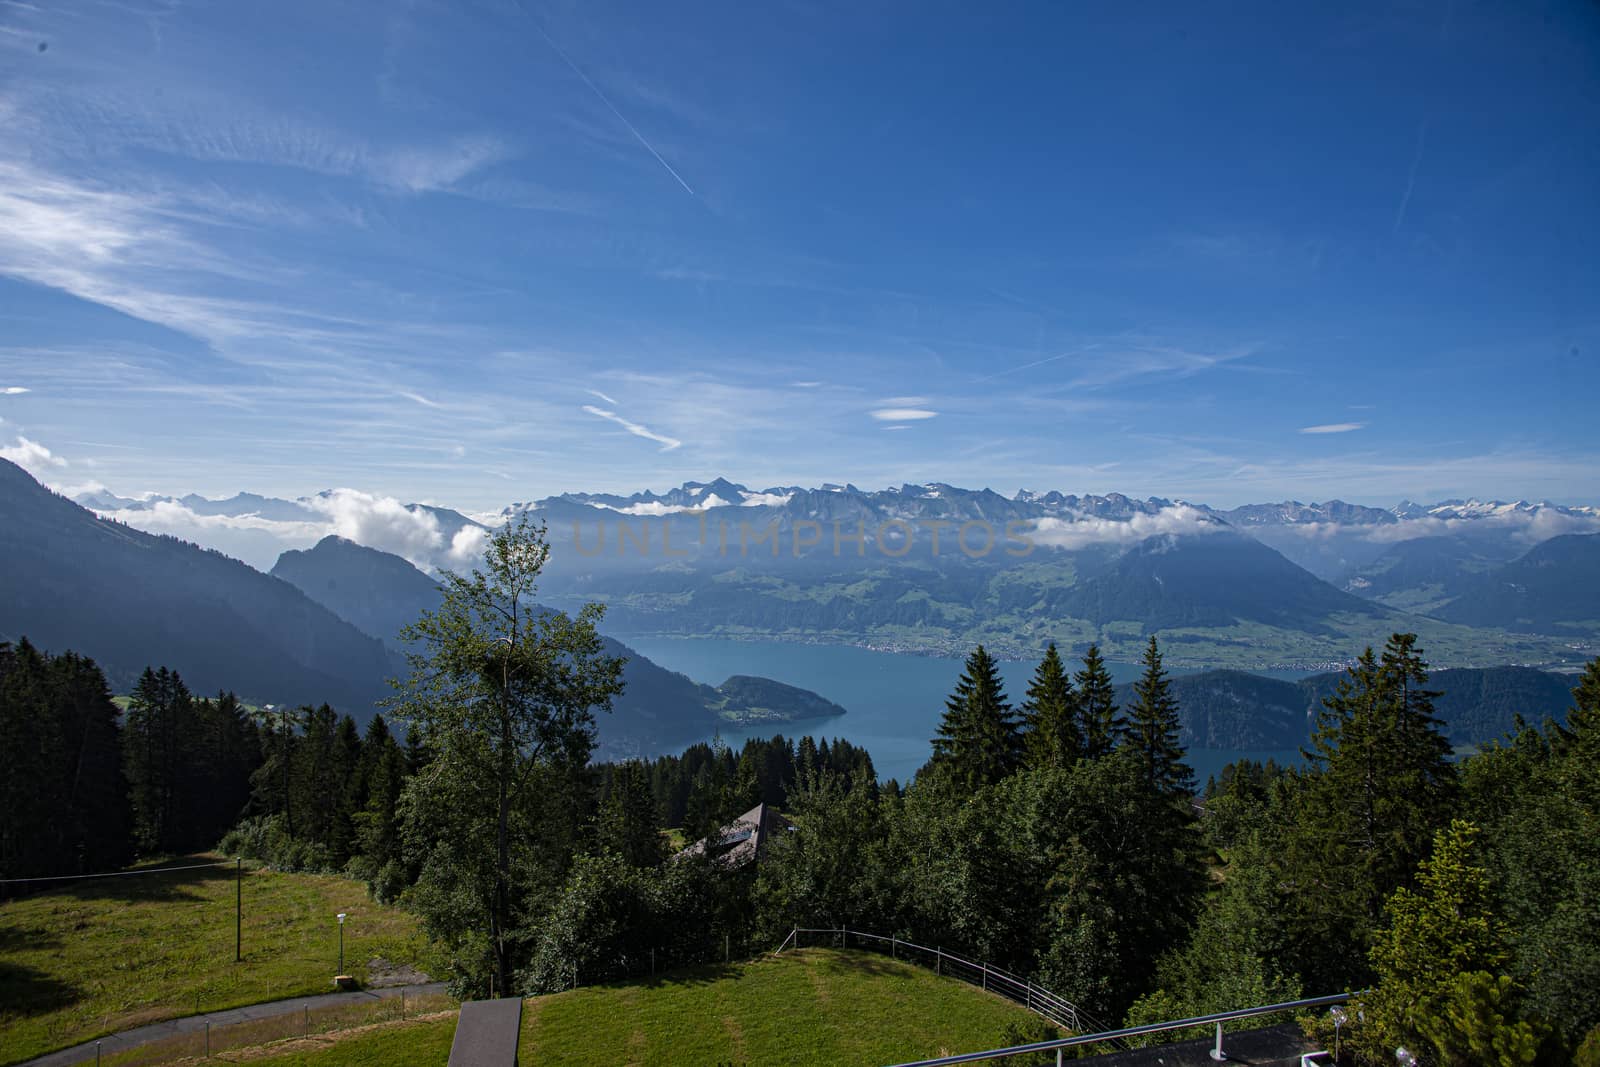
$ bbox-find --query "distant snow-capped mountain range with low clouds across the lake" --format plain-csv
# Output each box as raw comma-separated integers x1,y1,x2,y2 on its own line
72,478,1600,669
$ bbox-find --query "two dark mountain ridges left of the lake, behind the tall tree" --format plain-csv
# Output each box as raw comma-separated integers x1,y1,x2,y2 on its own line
0,461,845,757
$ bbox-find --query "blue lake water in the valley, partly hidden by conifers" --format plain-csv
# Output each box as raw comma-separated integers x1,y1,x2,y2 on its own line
614,633,1301,785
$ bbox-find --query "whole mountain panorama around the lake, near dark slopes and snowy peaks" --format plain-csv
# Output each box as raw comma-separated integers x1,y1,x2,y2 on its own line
9,462,1600,757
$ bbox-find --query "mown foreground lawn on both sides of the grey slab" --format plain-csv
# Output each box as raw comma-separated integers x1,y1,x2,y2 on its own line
190,949,1035,1067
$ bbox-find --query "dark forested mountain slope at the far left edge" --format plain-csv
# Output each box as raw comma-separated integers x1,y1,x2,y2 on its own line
0,461,398,715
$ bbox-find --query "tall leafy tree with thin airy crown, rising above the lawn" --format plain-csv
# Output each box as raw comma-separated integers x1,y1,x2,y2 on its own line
394,514,622,993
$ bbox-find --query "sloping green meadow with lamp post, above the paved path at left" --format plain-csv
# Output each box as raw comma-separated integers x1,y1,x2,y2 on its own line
0,857,427,1064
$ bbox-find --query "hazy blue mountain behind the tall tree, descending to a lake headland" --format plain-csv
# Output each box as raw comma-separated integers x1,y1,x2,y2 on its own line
272,537,845,758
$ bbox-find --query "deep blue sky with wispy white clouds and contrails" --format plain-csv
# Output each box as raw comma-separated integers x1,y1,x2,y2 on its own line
0,0,1600,509
